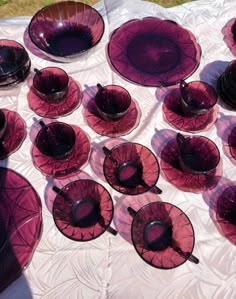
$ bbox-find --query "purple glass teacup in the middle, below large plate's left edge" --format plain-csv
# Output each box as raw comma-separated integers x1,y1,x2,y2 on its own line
95,84,131,120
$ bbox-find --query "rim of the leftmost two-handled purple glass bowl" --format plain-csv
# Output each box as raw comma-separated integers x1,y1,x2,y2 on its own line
52,179,114,242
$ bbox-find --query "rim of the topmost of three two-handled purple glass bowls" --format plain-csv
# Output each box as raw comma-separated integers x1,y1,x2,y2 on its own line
103,141,161,196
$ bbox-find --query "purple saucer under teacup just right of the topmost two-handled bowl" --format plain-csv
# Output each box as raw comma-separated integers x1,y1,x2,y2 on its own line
160,138,222,193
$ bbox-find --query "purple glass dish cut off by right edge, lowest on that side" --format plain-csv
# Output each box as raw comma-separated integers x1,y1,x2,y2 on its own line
216,185,236,244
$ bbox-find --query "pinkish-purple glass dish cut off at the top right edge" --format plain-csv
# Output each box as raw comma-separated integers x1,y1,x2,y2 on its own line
222,18,236,56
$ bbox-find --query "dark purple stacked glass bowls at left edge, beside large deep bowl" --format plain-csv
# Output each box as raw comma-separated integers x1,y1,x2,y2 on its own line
0,39,31,88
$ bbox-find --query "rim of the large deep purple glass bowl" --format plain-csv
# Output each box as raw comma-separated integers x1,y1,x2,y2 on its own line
28,1,105,58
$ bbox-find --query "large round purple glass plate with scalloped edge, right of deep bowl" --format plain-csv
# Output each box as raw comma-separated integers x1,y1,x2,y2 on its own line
108,17,201,87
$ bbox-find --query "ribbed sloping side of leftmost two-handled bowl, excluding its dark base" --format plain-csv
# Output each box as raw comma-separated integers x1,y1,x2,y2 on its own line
53,179,114,241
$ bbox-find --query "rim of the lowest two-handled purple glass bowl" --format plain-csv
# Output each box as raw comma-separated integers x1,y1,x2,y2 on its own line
131,201,195,270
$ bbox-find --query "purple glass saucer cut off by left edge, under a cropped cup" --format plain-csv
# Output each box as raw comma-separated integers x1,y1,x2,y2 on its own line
0,109,27,160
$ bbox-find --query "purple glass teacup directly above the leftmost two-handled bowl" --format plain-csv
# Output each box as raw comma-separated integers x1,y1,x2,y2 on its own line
35,121,76,159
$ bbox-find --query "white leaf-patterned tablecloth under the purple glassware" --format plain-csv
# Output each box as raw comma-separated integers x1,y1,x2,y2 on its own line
0,0,236,299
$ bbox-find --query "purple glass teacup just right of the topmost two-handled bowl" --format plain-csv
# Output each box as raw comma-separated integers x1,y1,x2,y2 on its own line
176,133,220,174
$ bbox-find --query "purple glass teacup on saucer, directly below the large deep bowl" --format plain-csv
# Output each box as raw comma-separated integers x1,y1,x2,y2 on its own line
33,67,69,103
